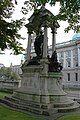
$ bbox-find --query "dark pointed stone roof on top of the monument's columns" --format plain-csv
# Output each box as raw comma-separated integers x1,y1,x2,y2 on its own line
25,6,60,34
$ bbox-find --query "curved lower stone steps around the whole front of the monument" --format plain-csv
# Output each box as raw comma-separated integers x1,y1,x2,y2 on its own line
0,97,80,116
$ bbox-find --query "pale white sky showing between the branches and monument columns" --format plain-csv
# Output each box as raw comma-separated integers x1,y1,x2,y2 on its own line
0,0,74,67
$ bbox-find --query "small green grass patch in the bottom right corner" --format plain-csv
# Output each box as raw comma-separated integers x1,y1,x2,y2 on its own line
58,114,80,120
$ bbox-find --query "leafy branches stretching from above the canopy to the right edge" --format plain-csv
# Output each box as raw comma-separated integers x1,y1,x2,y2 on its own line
22,0,80,32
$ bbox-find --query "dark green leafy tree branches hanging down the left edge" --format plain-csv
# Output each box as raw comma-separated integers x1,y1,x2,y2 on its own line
0,0,24,54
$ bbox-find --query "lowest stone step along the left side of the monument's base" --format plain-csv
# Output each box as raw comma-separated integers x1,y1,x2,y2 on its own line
0,99,58,116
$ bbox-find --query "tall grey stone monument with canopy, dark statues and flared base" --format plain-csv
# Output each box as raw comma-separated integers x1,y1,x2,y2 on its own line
0,6,79,115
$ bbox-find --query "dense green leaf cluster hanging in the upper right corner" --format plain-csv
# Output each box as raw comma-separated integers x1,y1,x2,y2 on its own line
58,0,80,32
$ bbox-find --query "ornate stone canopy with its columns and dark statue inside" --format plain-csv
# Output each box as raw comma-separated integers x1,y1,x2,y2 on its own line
25,5,60,74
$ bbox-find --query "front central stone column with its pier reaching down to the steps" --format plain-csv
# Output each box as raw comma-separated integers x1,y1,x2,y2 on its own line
41,25,50,104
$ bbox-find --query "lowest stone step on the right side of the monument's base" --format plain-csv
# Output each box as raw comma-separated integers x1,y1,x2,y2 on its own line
58,102,80,113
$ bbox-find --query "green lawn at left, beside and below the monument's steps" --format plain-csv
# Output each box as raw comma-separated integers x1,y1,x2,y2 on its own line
0,92,44,120
